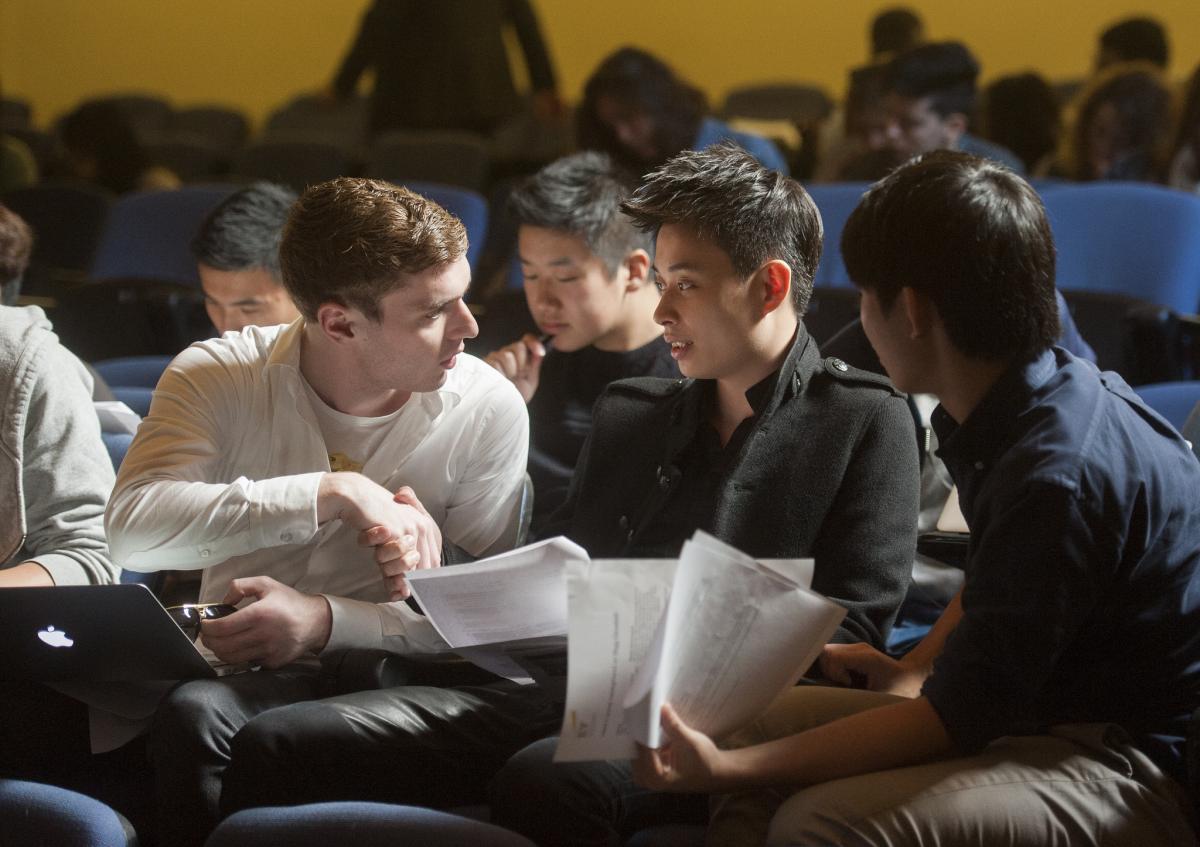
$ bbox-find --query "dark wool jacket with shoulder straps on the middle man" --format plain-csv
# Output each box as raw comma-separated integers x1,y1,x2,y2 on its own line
542,326,919,649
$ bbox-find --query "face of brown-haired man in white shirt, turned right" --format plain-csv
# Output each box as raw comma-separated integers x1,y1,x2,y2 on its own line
355,251,479,392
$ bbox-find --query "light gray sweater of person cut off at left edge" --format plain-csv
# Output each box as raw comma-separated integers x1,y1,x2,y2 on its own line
0,306,120,585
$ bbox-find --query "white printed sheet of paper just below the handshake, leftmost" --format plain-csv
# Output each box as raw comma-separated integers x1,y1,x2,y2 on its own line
408,536,588,649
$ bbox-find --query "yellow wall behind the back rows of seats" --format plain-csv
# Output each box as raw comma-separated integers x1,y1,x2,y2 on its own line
0,0,1200,129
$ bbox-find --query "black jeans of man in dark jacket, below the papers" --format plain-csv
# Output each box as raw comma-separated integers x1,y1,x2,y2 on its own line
491,738,708,847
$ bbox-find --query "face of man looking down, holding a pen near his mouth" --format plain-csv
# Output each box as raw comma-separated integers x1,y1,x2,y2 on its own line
517,226,643,353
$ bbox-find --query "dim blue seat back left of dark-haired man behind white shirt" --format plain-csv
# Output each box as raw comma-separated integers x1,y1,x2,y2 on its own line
91,185,236,289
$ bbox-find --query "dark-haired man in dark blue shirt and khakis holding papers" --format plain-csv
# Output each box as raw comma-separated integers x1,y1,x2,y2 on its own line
635,151,1200,845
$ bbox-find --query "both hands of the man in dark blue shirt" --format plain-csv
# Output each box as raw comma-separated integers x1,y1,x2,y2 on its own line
634,643,929,794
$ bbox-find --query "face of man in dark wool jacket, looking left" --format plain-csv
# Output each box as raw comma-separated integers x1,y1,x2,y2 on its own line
652,223,761,380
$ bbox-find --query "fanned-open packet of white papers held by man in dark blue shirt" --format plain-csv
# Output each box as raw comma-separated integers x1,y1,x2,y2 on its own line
556,533,846,761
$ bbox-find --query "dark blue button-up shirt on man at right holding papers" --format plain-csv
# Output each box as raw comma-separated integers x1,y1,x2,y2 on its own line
924,348,1200,781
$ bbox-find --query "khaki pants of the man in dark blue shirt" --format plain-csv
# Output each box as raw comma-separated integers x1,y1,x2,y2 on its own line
707,686,1196,847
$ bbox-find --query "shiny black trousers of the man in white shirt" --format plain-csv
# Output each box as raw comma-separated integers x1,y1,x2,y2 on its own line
150,666,562,847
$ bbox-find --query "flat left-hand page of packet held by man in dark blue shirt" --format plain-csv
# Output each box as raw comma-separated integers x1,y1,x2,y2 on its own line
554,559,677,762
